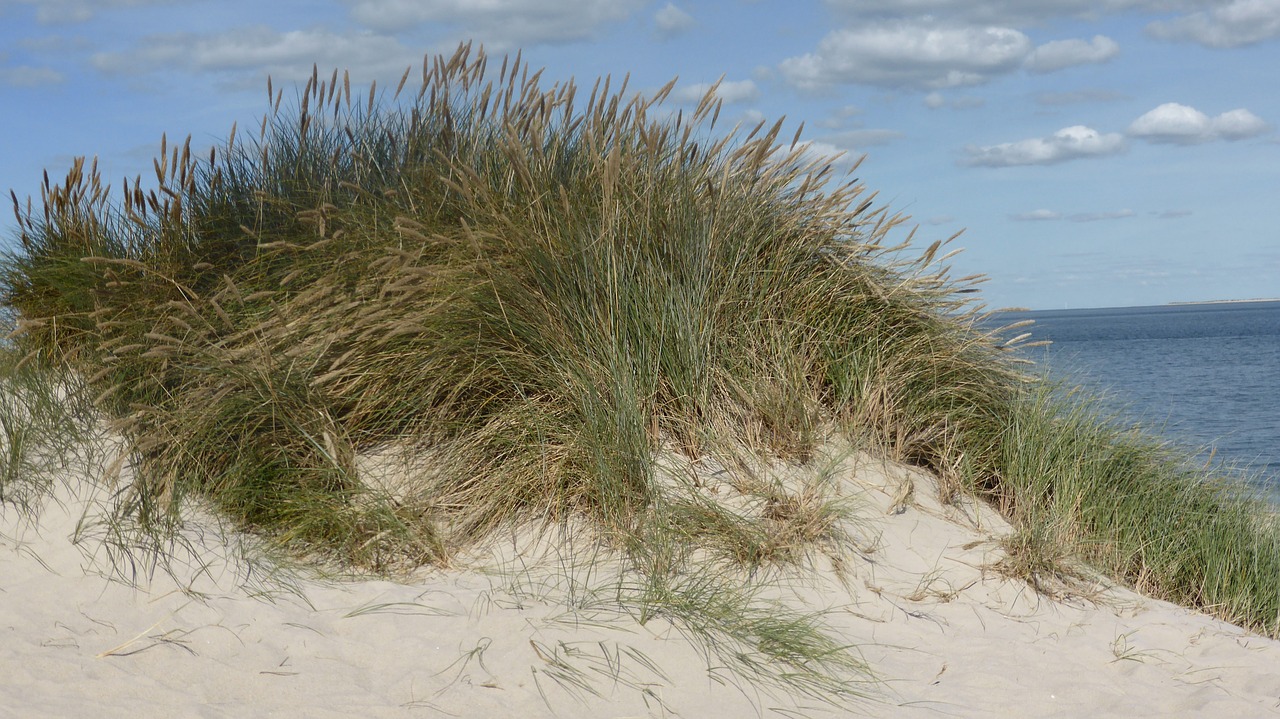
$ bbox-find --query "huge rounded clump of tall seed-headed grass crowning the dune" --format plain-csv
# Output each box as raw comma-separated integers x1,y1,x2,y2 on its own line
0,43,1011,563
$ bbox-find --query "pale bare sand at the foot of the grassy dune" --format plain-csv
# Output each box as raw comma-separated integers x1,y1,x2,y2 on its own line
0,445,1280,719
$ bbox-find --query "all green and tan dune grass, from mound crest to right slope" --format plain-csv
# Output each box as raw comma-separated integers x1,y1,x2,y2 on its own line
0,46,1280,693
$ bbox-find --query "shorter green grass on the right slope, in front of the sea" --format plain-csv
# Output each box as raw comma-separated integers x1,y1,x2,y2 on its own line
1001,384,1280,636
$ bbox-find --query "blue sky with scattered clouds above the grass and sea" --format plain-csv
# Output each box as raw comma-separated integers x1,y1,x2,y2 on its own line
0,0,1280,308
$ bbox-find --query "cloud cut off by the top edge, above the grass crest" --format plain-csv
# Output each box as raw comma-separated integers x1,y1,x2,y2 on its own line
344,0,646,49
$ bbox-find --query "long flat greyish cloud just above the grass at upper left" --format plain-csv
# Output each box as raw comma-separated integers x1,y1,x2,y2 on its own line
91,27,421,81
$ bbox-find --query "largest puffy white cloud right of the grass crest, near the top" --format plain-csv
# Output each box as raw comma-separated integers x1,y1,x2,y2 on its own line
780,22,1032,90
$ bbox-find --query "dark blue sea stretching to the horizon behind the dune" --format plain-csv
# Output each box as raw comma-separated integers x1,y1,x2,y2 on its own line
996,301,1280,505
